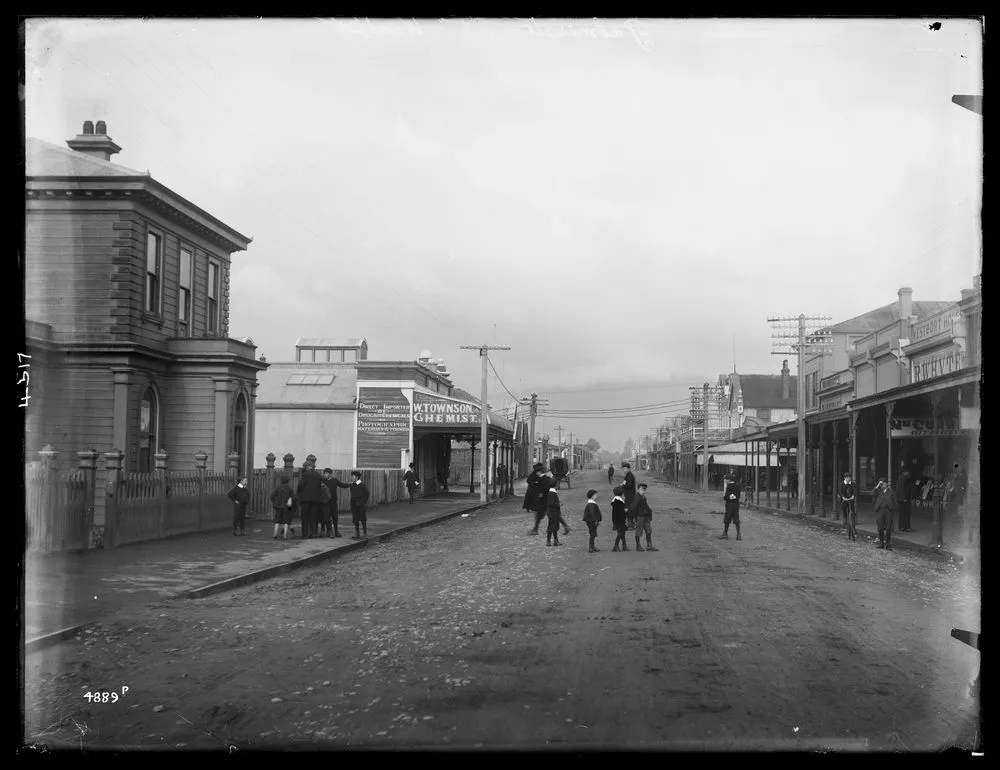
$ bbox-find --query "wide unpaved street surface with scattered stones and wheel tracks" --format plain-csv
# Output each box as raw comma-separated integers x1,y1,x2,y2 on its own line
25,472,980,750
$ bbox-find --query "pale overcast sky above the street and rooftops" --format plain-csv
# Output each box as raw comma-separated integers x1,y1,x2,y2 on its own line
25,19,982,449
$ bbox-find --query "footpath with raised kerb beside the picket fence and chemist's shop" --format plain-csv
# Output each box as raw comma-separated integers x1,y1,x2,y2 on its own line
23,481,524,652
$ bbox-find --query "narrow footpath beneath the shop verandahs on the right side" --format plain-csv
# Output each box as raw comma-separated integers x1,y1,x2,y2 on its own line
661,479,980,562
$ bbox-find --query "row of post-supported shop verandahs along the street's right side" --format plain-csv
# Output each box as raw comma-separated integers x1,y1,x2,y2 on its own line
661,366,981,512
